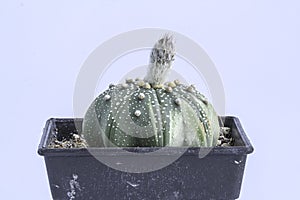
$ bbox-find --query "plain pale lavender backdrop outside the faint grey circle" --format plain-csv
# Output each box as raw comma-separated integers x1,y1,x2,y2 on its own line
0,0,300,200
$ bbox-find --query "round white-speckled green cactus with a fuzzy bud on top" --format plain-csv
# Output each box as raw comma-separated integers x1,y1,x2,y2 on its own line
82,35,220,147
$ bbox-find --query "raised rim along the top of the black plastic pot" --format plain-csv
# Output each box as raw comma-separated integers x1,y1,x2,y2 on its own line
38,116,254,157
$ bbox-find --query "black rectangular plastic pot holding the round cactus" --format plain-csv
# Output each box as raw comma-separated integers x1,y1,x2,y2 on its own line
38,117,253,200
